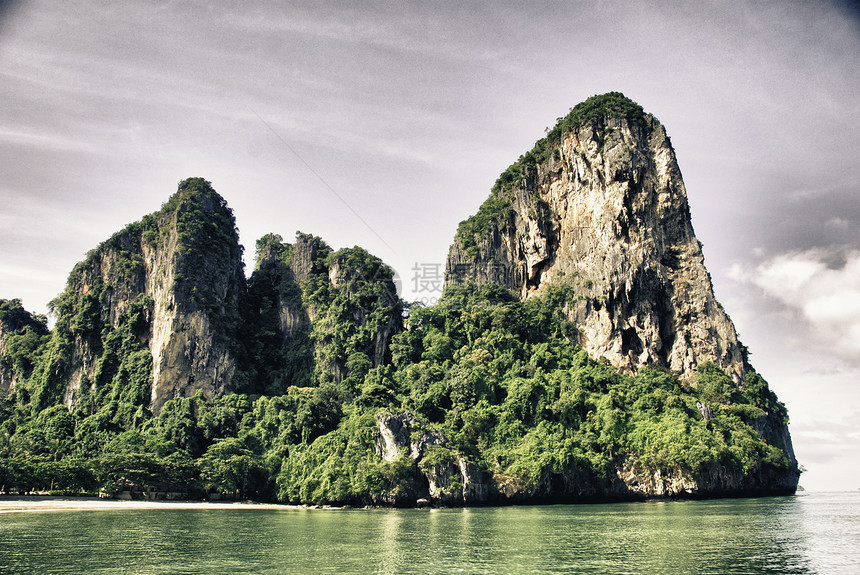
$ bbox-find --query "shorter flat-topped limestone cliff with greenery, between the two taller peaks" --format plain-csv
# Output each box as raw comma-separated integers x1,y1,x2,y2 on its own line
246,233,402,393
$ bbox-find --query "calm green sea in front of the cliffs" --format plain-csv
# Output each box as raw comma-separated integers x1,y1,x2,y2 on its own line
0,493,860,575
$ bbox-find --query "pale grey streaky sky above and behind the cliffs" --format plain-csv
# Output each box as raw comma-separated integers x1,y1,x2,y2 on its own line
0,0,860,491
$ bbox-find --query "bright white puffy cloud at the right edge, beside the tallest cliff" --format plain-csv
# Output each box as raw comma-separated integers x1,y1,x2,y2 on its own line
728,248,860,365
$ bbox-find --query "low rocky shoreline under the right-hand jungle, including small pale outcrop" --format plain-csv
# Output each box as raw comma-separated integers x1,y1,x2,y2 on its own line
376,410,797,506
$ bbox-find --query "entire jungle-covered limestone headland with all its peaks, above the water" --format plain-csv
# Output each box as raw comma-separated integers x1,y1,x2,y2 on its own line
0,101,799,506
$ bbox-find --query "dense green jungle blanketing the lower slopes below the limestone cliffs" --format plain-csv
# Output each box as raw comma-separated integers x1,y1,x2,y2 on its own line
0,280,789,504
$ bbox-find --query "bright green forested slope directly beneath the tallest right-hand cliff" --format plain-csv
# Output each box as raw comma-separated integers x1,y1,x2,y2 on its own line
386,286,789,491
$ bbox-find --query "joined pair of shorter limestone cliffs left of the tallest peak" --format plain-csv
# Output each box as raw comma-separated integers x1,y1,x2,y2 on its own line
8,178,402,419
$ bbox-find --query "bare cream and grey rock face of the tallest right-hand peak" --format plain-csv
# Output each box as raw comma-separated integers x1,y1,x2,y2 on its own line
446,93,745,382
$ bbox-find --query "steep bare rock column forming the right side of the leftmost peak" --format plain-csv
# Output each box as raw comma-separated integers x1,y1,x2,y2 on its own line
143,184,245,410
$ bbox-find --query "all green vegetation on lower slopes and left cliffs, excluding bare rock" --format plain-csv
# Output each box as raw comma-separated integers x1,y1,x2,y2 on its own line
0,176,796,504
